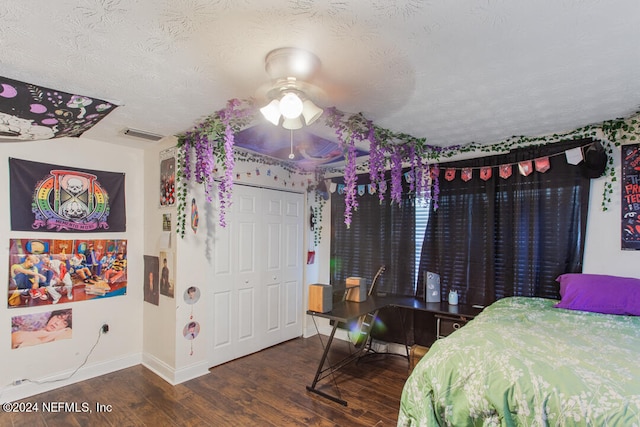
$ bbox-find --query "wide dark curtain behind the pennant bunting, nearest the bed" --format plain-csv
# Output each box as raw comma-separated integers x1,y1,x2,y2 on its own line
417,139,592,305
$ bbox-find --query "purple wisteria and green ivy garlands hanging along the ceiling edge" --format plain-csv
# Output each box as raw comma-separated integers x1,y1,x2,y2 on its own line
176,99,640,237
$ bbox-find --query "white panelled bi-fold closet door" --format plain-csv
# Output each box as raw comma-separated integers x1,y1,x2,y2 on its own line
207,185,304,366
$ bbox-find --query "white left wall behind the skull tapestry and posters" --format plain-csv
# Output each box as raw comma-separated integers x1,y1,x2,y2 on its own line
0,138,144,402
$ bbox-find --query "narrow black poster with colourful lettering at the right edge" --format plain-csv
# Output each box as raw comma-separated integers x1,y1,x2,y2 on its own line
621,144,640,250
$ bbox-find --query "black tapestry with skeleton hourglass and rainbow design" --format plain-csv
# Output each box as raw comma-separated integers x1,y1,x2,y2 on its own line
9,158,126,232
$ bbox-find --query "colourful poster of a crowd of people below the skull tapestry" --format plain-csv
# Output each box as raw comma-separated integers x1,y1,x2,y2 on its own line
7,239,127,308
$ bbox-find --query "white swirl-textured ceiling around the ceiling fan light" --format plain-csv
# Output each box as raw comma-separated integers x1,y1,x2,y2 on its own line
0,0,640,153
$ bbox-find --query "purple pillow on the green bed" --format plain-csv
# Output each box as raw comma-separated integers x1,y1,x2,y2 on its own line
555,273,640,316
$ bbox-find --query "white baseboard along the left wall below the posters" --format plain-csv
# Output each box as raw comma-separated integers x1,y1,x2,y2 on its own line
0,353,142,403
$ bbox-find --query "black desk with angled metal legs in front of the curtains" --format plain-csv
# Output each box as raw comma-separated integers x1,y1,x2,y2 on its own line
307,295,482,406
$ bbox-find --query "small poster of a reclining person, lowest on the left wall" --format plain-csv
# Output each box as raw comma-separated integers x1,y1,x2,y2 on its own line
11,308,72,349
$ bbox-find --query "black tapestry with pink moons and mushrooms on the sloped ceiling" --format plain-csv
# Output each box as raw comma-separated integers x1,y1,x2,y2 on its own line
0,77,117,141
